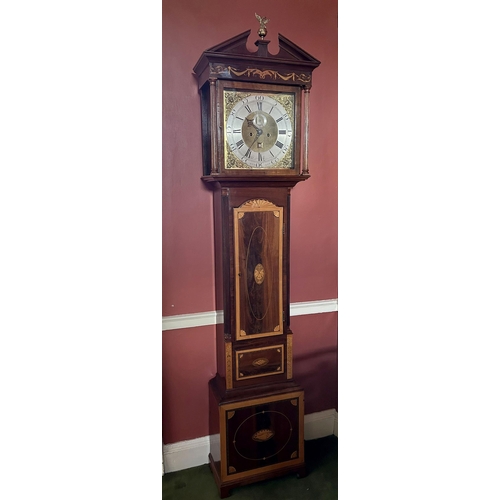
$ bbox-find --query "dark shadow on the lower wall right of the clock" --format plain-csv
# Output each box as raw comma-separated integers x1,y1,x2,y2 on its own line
293,347,338,414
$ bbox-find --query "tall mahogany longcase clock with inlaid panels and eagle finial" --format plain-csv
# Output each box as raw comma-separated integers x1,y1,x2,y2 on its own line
194,16,320,498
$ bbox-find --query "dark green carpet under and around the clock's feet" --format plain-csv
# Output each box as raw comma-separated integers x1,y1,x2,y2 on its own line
162,436,338,500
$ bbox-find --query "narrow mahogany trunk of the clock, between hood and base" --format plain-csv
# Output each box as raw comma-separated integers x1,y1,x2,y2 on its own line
209,179,302,389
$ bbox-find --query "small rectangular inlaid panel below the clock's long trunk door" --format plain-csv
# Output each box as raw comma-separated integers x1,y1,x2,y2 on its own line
235,344,285,380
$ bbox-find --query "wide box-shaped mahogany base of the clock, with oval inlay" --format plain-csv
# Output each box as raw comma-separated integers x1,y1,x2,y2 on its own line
209,377,306,498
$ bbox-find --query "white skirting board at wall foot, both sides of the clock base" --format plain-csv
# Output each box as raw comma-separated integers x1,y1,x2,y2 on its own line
162,409,338,473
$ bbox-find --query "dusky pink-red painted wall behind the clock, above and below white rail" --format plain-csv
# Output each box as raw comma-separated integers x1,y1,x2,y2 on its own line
162,0,338,443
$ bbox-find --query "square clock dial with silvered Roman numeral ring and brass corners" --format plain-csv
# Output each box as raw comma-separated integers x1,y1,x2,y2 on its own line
224,90,294,169
